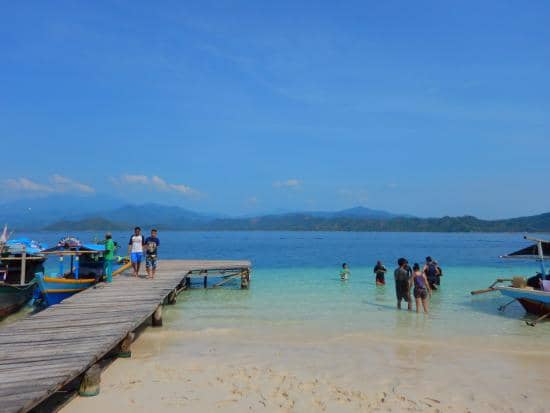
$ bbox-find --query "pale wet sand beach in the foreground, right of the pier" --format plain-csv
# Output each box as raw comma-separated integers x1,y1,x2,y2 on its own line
62,326,550,413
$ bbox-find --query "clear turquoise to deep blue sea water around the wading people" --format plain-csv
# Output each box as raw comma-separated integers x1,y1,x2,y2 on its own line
16,232,550,344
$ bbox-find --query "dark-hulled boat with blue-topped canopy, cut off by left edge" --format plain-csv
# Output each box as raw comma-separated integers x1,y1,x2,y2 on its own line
0,227,46,319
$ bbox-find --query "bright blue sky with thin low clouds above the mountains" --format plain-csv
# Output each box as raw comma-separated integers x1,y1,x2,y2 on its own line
0,0,550,217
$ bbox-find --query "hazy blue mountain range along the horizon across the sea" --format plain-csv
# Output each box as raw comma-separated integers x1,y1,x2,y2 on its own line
0,196,550,232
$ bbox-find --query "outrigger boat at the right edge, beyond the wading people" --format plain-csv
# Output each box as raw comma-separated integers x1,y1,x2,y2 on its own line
472,236,550,326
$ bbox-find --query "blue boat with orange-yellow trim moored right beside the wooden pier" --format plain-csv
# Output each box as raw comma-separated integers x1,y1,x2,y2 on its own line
37,237,127,306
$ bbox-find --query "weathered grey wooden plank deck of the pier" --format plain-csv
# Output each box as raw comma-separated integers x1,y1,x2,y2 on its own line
0,260,251,412
